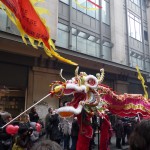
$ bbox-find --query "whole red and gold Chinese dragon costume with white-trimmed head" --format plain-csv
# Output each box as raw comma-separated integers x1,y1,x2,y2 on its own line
50,67,150,150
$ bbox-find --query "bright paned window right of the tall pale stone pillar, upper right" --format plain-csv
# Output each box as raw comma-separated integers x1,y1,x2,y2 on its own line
128,12,142,41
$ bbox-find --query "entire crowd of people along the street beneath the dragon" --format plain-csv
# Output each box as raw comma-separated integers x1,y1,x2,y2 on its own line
0,107,150,150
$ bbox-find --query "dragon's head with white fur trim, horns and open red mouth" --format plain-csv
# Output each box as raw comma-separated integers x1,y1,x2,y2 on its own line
51,67,104,116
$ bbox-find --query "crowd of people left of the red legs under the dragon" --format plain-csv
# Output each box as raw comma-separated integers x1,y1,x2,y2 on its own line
0,107,79,150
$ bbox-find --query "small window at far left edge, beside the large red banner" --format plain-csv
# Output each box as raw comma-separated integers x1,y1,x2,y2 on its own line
0,9,7,31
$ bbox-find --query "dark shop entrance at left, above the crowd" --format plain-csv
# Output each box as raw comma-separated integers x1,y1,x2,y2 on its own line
0,63,28,117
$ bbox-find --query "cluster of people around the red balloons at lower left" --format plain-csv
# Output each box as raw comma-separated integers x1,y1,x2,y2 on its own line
0,108,44,150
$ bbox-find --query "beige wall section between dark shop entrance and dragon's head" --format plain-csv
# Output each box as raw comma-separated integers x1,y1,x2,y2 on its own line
26,67,62,109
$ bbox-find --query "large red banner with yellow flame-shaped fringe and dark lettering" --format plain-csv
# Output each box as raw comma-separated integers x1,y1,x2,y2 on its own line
0,0,77,65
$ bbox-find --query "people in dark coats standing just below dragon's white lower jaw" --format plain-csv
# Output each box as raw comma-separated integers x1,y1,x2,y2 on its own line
45,107,79,150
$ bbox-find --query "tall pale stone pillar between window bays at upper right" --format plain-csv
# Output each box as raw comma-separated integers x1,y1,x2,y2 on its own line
110,0,126,64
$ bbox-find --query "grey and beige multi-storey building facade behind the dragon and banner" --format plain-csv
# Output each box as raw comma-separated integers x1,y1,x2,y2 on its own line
0,0,150,116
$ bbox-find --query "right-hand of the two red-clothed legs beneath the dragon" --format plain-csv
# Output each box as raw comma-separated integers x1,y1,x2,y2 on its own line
99,114,111,150
